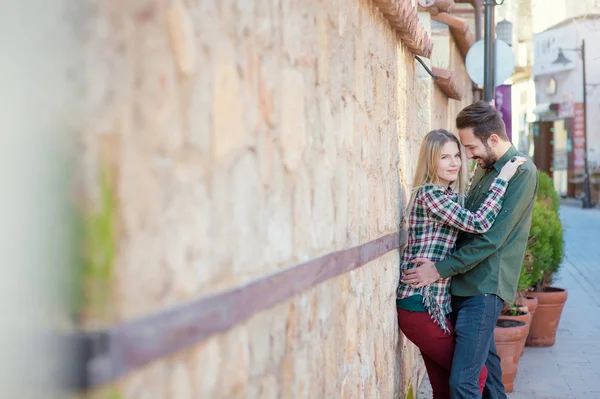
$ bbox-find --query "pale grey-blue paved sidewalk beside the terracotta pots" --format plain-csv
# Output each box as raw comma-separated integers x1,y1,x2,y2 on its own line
418,204,600,399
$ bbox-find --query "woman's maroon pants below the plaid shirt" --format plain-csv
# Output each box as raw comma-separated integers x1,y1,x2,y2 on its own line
398,308,488,399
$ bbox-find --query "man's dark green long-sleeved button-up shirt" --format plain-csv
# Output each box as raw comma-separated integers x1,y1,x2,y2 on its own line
435,146,538,303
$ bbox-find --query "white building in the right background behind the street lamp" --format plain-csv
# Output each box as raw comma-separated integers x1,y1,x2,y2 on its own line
531,14,600,200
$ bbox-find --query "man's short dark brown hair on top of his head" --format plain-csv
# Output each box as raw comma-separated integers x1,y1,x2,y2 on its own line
456,101,509,147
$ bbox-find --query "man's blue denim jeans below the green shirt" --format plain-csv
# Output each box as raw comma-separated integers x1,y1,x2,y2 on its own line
450,294,506,399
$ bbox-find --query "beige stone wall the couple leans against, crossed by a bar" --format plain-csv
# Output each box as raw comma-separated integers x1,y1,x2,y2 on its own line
78,0,472,399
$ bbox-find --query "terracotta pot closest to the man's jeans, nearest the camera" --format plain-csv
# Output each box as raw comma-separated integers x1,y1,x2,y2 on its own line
494,320,527,393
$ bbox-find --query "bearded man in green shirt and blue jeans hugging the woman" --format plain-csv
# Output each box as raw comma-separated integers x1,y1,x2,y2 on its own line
403,101,537,399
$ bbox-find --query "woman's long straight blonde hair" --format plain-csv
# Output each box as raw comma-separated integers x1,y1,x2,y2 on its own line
406,129,466,218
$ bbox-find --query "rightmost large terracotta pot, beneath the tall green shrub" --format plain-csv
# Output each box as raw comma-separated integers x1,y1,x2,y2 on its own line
526,287,568,346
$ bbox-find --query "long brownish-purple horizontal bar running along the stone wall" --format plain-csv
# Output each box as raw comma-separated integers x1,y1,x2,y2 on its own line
63,230,407,390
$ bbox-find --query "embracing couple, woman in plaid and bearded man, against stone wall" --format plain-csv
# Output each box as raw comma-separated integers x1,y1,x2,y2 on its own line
396,102,537,399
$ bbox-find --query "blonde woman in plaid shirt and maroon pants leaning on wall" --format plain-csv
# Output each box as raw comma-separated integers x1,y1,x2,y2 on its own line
396,130,525,399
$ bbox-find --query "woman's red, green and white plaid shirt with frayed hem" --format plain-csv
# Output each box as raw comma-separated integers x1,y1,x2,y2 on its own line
396,178,508,331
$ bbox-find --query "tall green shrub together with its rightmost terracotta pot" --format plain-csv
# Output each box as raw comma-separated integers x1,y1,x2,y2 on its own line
520,172,568,346
